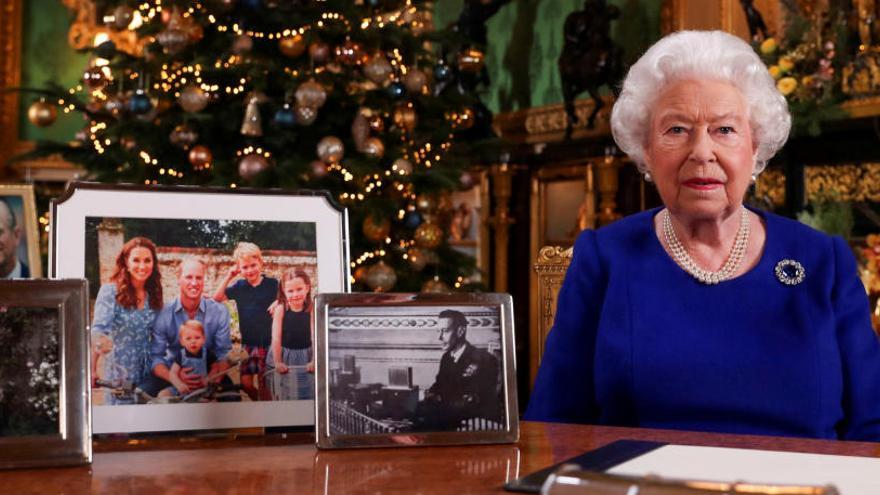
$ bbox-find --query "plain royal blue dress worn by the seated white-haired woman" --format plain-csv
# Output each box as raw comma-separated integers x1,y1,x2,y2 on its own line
524,210,880,441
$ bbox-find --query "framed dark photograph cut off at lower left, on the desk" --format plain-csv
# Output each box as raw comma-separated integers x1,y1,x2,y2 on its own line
0,280,92,468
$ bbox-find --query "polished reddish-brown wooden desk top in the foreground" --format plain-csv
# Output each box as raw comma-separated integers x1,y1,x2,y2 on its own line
0,422,880,495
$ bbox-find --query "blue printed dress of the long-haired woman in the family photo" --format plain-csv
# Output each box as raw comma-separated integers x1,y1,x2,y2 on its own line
92,284,158,405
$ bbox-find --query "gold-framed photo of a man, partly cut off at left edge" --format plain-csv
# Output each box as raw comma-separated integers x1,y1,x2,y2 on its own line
0,184,43,279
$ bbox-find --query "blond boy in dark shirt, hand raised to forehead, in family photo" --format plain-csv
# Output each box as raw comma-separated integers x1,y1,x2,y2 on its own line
214,242,278,400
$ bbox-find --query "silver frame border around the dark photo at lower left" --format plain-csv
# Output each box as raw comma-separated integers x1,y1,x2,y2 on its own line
0,280,92,469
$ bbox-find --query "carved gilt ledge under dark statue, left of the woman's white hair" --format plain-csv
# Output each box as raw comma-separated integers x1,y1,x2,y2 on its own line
493,95,614,144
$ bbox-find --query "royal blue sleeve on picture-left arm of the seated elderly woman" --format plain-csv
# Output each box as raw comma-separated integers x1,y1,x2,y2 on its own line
524,230,606,423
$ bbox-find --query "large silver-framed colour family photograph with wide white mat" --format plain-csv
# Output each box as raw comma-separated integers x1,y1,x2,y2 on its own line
50,183,350,433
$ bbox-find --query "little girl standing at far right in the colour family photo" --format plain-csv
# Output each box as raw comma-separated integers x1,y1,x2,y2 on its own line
266,267,315,400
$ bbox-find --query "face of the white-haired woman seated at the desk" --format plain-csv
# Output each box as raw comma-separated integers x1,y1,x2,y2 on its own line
645,80,755,220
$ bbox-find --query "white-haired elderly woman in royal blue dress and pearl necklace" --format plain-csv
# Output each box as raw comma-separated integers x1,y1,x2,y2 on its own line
525,31,880,440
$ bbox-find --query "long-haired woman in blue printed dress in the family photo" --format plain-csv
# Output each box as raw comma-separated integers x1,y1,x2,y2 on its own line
91,237,163,405
